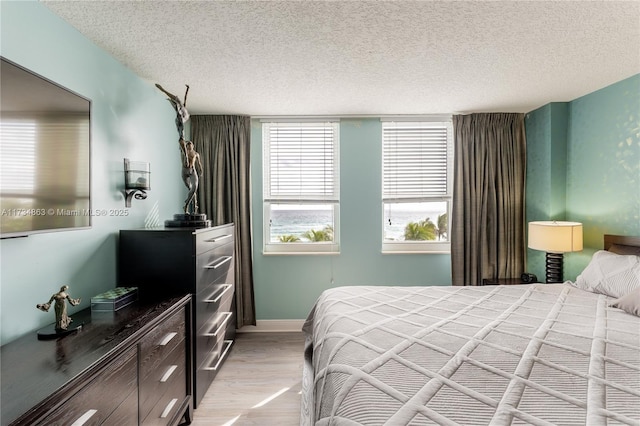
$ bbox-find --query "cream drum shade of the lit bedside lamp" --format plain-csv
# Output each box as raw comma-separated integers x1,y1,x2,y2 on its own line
529,221,582,253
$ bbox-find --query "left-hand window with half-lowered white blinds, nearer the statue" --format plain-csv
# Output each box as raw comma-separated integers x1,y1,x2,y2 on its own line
262,121,340,253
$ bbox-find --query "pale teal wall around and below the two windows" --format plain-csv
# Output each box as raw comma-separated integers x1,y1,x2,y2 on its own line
251,118,451,320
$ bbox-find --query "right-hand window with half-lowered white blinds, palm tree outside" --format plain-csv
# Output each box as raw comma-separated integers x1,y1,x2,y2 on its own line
382,119,453,252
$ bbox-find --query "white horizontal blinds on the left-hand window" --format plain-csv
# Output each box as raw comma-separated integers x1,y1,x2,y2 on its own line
263,122,339,202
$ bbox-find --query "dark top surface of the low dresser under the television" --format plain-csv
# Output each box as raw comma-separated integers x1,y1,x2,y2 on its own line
0,295,191,425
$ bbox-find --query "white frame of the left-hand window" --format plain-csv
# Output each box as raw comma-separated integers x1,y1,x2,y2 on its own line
261,117,340,254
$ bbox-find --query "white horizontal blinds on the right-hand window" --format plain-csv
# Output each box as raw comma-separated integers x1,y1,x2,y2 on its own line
382,122,451,202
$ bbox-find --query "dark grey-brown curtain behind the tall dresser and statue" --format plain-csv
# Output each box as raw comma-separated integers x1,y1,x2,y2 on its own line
191,115,256,328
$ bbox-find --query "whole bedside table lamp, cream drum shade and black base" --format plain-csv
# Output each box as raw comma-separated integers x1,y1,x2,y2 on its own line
529,221,582,283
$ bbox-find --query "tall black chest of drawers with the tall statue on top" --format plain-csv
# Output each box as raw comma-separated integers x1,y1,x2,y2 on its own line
118,224,236,408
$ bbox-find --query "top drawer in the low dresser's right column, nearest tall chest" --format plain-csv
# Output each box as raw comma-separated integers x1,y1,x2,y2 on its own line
139,310,186,381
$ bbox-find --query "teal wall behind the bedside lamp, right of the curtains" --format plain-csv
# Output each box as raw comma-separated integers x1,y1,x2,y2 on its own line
526,74,640,280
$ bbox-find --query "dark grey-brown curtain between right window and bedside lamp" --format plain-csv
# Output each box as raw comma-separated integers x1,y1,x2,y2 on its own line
451,113,526,285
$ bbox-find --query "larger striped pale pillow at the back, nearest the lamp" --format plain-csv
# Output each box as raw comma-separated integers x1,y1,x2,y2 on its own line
575,250,640,299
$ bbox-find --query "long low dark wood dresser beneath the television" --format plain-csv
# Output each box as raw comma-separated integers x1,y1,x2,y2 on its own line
0,295,192,426
